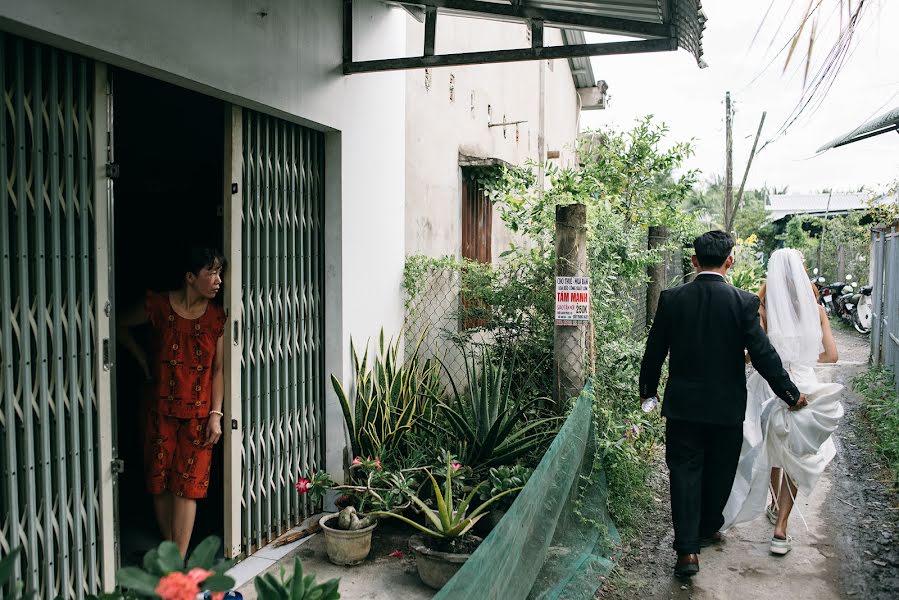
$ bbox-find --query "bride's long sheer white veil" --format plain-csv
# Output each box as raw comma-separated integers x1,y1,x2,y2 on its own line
765,248,824,365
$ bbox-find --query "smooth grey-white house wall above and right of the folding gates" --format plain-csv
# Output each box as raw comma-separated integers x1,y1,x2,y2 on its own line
0,0,407,476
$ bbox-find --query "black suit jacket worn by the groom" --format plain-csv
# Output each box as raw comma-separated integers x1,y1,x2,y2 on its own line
640,275,799,425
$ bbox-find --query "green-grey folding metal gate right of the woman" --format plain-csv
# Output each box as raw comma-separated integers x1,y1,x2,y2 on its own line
240,110,325,553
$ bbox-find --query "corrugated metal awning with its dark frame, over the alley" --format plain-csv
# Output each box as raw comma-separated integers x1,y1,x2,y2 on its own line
343,0,706,75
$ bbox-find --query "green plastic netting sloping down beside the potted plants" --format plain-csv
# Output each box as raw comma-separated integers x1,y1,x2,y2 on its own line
434,382,620,600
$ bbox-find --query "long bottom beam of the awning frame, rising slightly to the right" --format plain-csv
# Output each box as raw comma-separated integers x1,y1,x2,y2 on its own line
343,36,677,75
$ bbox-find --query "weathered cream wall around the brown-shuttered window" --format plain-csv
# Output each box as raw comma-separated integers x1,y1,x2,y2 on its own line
406,15,578,260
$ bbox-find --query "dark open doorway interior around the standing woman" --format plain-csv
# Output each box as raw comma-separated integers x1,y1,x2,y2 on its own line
111,69,227,565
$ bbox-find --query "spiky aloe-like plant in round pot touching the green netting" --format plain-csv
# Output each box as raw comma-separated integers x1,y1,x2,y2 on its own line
371,457,521,590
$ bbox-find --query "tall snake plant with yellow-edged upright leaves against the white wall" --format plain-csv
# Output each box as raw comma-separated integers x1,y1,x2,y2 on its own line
331,329,442,457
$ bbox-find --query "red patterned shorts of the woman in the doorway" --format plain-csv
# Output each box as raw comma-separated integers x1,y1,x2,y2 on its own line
144,411,212,499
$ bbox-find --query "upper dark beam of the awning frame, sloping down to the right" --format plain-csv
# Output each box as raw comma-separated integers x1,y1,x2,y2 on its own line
395,0,674,37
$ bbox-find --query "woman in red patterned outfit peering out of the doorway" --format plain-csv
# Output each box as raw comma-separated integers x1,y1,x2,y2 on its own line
118,248,226,556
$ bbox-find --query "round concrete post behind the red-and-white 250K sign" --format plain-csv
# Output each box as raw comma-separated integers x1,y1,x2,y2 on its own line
553,204,592,409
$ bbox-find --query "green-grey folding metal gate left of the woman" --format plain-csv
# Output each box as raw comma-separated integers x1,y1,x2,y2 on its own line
0,33,115,598
